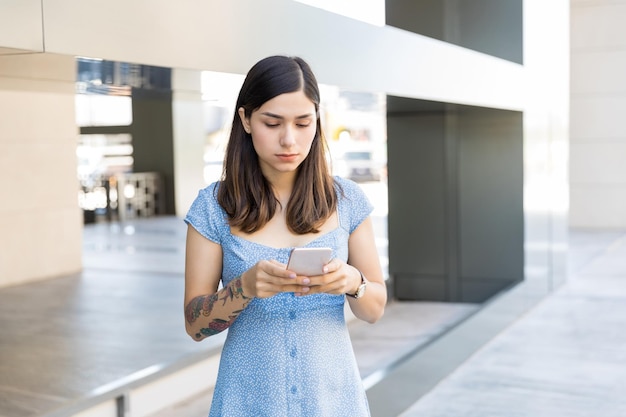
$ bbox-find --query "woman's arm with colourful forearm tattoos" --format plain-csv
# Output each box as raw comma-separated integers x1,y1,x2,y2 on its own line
185,226,253,341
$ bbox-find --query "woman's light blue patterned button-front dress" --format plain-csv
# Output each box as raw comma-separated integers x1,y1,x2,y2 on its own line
185,177,372,417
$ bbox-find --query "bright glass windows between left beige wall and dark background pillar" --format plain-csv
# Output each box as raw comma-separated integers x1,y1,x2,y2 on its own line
75,57,171,223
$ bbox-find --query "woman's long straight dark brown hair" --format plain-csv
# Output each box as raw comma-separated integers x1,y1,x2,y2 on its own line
217,56,337,234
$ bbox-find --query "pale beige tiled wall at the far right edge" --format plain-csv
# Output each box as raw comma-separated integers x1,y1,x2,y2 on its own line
570,0,626,228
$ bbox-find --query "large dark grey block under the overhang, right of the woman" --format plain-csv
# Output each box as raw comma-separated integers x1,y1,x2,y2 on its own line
387,101,524,302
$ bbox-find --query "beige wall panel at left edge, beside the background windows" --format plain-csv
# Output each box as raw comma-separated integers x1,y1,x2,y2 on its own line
0,54,82,287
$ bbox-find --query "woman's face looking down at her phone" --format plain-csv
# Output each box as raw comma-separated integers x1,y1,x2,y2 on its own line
239,91,317,178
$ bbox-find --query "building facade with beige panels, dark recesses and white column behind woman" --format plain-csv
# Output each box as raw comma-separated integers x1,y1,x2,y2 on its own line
0,0,564,302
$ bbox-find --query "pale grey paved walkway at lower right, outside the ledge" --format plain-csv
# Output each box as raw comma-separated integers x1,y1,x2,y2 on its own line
400,230,626,417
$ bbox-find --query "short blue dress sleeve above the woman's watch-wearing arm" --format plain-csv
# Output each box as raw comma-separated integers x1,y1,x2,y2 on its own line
335,177,374,233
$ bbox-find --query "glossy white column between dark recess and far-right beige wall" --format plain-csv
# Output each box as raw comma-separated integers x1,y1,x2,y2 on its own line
524,0,569,289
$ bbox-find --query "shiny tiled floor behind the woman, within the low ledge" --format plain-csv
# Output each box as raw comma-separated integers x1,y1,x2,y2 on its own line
0,217,477,417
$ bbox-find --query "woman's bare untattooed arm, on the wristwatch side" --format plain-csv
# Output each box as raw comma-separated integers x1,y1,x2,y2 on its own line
345,217,387,323
